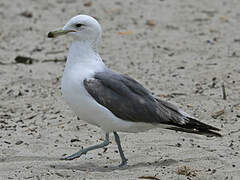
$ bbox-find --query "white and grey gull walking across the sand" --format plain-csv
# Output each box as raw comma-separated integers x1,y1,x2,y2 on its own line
48,15,221,167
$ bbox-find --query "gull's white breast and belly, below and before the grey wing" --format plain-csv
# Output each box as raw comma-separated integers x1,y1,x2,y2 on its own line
62,64,157,132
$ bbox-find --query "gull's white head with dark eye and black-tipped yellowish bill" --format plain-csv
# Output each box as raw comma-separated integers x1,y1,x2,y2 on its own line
48,15,102,46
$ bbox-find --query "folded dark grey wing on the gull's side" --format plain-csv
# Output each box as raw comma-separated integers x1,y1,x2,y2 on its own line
84,70,188,124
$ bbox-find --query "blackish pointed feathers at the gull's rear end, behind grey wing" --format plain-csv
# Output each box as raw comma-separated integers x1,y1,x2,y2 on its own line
167,117,222,137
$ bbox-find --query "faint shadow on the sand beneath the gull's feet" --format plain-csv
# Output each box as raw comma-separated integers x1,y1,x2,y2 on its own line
50,159,178,172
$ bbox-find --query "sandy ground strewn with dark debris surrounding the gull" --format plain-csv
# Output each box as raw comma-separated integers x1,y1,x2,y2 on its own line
0,0,240,180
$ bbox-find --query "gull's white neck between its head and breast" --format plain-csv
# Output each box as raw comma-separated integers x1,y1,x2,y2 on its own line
67,41,102,64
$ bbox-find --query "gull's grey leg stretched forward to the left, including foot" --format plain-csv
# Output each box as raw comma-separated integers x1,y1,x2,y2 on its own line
61,133,109,160
